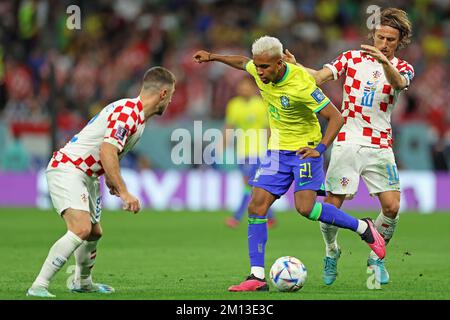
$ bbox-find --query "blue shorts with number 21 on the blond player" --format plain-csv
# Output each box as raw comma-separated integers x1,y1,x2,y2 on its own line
248,150,325,197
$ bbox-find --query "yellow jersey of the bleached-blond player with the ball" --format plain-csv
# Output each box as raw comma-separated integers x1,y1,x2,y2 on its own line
245,60,330,150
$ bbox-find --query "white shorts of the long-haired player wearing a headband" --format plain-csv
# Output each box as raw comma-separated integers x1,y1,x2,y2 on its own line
326,144,400,199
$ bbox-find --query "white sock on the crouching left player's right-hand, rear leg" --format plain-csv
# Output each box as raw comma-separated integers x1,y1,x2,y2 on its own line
74,240,98,287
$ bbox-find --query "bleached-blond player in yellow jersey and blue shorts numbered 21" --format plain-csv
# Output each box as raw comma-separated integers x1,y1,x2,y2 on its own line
193,36,385,292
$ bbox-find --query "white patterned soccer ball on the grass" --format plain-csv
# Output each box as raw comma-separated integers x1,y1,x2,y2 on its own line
270,256,308,292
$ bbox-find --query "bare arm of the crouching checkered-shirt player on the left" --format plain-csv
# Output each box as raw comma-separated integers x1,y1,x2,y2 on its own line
100,142,141,213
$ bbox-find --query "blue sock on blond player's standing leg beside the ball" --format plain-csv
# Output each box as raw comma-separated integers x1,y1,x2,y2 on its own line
248,214,267,267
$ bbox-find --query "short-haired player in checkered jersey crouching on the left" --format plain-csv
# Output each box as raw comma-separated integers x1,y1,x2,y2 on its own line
27,67,175,298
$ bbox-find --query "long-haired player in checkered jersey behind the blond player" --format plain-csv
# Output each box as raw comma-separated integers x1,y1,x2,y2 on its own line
286,8,414,285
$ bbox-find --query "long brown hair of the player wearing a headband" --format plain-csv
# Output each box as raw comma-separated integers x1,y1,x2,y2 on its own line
369,8,412,49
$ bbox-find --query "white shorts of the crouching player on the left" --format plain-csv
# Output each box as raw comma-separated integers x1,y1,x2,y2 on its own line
45,164,102,224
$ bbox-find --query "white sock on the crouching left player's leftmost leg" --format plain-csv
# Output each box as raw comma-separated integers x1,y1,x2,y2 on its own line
32,231,83,288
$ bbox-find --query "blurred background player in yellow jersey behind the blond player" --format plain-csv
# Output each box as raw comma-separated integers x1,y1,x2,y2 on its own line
225,77,275,228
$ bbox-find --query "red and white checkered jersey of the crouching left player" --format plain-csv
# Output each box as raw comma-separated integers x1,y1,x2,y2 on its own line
49,97,145,177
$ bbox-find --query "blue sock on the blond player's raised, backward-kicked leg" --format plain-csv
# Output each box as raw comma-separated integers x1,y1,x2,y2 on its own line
308,202,358,231
